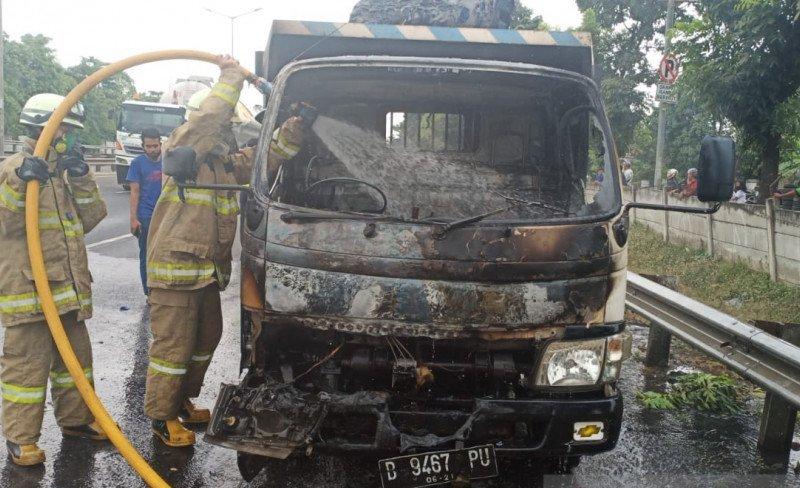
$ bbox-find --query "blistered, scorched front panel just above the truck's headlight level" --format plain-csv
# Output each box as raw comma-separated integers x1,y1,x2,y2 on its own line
265,263,608,336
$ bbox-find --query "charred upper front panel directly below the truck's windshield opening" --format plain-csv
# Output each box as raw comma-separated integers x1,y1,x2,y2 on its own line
266,209,624,283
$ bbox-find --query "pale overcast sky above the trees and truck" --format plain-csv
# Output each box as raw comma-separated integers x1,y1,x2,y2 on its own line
2,0,581,104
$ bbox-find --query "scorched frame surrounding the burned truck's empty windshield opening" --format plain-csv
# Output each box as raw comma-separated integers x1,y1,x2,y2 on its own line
252,56,622,226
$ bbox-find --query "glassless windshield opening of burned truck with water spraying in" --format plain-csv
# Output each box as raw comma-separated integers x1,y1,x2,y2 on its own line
262,68,619,223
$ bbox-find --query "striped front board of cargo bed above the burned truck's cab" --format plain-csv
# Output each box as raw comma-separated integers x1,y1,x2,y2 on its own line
256,20,593,81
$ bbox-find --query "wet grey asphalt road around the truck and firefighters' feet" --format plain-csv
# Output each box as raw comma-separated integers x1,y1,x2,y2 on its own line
0,175,800,488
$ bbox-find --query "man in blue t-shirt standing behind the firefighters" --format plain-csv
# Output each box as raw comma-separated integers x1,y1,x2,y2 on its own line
125,128,161,296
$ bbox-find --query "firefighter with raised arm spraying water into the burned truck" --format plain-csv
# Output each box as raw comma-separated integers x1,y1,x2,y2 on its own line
144,56,253,447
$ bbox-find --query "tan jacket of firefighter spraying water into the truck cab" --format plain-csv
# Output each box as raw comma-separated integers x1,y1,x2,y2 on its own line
147,68,253,290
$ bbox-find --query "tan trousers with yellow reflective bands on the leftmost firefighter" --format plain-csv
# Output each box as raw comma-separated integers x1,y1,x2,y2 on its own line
0,312,94,444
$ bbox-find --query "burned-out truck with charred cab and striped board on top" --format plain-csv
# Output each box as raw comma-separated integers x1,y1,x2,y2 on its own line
206,21,732,487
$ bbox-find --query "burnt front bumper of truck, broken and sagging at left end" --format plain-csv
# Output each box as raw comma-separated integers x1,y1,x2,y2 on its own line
205,385,622,459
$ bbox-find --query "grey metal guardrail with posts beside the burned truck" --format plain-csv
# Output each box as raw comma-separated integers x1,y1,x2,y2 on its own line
626,272,800,466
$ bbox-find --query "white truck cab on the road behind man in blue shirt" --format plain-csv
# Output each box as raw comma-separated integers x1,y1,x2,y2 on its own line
114,100,186,189
